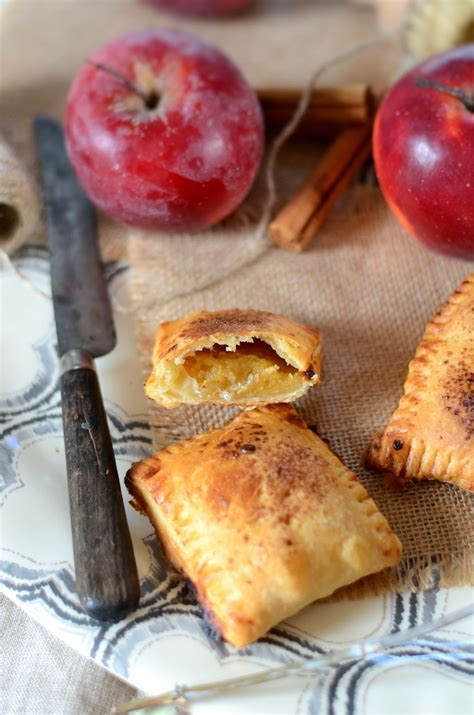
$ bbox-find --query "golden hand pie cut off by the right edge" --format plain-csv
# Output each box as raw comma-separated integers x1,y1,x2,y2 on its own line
366,273,474,490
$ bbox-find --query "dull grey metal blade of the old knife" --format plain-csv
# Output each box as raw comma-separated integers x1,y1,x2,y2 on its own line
35,117,116,364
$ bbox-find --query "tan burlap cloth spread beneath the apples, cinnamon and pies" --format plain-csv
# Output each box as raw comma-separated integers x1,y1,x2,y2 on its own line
0,0,474,608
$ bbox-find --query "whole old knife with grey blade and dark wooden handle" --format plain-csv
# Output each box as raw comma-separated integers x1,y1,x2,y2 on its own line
34,117,139,620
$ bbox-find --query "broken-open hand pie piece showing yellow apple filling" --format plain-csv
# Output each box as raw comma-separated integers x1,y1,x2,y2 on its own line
145,310,322,407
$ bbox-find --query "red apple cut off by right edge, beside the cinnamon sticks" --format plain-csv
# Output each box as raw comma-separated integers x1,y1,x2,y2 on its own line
373,44,474,258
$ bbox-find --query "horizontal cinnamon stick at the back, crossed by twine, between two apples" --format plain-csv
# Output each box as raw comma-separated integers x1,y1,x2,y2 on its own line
257,84,373,134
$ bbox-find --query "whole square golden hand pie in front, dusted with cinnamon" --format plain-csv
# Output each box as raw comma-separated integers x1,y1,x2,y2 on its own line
126,404,401,648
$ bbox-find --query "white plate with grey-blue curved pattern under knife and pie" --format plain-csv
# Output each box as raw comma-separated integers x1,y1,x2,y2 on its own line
0,245,474,715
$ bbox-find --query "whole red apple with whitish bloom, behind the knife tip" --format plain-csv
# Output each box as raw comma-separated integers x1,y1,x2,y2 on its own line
66,29,263,231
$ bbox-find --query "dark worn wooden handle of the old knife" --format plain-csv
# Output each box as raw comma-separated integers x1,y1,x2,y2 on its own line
60,360,140,620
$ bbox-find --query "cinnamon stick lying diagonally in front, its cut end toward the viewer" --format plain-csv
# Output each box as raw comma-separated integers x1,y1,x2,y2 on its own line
268,123,372,253
